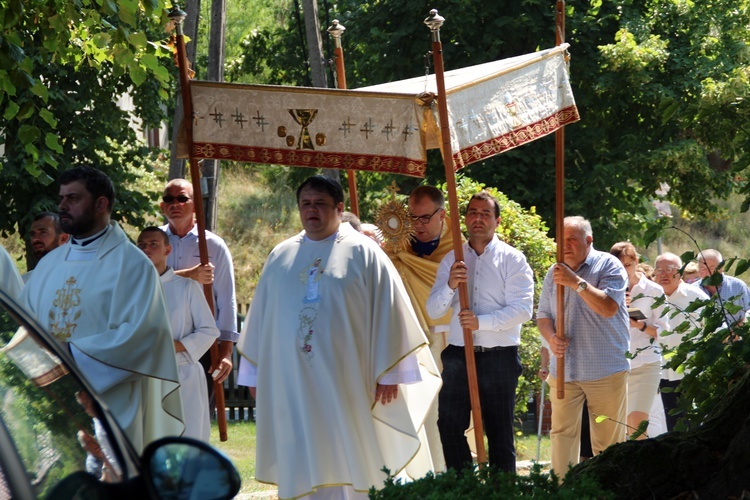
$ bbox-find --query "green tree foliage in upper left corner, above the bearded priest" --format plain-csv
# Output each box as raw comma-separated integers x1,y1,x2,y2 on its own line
0,0,172,242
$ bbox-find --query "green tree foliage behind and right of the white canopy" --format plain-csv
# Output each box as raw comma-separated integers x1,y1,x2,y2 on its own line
232,0,750,247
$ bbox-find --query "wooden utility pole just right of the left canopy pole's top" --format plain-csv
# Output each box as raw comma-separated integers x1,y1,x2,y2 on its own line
201,0,227,231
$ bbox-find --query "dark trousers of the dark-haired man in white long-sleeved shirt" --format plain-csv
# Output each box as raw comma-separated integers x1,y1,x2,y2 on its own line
438,345,521,472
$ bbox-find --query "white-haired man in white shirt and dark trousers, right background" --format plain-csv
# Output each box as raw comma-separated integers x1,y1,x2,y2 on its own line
654,252,708,431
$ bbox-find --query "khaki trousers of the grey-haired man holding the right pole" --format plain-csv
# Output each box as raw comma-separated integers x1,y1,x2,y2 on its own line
547,372,628,479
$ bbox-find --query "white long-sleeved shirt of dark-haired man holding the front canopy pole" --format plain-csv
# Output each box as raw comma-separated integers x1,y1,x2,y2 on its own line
427,236,534,347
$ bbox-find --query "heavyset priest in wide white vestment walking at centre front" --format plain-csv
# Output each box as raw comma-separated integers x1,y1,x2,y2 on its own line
238,176,440,498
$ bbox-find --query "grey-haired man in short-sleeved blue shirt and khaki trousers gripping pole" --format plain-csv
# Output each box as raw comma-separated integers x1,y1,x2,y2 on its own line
537,217,630,476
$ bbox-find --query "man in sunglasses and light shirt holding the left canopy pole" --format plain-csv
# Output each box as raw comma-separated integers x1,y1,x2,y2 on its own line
159,179,239,398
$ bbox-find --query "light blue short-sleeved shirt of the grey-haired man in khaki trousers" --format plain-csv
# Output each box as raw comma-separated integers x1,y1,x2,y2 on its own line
537,246,630,382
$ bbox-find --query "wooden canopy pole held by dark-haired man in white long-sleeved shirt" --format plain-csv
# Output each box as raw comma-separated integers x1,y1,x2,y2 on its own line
424,9,487,467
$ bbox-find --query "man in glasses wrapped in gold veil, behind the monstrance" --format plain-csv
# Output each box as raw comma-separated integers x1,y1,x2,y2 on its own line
388,185,462,471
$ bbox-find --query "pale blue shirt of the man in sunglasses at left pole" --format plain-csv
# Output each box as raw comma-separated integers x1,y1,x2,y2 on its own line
161,224,240,342
